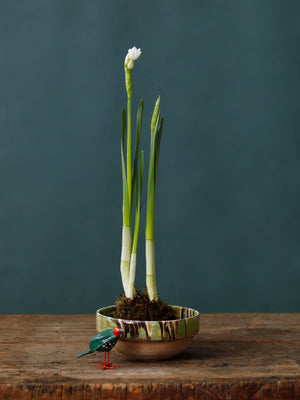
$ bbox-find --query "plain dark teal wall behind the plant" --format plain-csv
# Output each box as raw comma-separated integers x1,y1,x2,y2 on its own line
0,0,300,313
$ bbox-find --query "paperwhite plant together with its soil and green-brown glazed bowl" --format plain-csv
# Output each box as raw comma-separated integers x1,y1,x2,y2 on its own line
96,47,200,360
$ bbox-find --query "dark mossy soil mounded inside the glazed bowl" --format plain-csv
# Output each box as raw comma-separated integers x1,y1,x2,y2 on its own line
113,290,178,321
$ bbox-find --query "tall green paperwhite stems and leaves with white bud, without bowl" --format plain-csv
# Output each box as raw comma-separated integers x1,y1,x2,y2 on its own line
120,47,163,300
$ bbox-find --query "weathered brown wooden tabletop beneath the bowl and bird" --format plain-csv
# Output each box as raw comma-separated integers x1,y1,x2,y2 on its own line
0,314,300,400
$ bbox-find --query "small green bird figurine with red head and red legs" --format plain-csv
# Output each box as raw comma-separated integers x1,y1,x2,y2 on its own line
76,327,124,370
